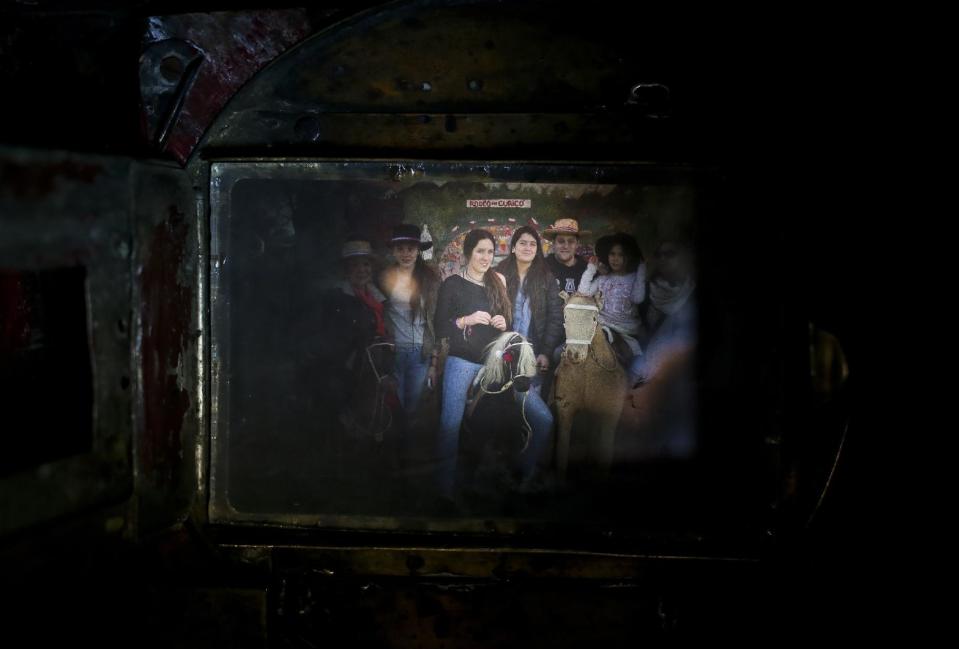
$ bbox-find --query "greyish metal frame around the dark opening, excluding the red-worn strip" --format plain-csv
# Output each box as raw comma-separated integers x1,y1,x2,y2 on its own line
0,149,132,532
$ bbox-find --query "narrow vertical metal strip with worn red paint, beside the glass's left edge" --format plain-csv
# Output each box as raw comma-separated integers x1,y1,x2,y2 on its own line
131,164,201,530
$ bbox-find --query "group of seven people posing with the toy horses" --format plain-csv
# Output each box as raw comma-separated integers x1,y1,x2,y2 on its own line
334,218,695,496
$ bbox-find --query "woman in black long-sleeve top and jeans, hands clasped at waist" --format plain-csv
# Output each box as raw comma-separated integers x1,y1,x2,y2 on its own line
435,230,512,496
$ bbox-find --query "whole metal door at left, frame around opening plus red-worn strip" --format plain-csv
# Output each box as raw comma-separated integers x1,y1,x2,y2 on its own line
0,150,199,531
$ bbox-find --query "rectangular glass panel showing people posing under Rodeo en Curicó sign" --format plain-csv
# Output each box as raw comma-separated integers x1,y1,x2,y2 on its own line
211,162,728,530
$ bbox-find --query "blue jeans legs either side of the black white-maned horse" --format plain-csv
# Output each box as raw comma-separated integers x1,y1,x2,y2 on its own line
438,356,553,497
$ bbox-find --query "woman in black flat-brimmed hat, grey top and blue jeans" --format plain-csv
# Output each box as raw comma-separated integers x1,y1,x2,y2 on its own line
380,223,440,415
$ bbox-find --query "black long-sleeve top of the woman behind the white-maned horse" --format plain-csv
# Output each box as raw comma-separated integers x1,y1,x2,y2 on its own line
434,271,509,363
